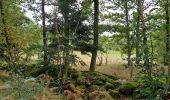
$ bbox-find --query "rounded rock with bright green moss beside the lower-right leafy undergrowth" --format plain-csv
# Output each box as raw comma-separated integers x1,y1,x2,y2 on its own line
119,82,138,96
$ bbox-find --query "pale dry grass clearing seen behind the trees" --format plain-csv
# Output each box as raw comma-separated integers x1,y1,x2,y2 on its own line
74,51,138,79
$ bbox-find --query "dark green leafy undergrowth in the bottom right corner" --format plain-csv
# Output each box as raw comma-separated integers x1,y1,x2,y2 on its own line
135,76,166,99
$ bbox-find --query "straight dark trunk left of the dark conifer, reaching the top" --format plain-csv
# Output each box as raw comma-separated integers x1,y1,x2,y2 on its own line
41,0,48,67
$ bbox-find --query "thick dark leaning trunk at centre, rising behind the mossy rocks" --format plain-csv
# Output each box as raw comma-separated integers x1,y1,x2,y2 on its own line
90,0,99,71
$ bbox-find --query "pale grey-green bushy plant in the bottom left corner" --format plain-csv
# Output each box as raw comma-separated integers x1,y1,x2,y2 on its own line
0,75,44,99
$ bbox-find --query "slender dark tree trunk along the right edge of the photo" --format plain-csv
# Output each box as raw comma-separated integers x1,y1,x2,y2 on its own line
165,0,170,93
